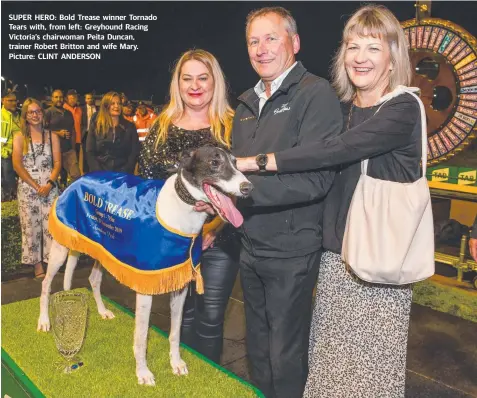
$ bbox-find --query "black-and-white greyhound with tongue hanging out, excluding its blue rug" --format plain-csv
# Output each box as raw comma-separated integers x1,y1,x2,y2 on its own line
38,146,253,385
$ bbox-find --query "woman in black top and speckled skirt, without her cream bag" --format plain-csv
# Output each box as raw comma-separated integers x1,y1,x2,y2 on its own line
238,6,422,398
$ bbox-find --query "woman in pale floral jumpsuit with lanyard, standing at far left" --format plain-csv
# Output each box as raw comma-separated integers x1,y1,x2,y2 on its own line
12,98,61,280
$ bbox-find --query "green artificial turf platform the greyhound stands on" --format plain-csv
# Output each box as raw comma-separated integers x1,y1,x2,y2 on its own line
2,289,262,398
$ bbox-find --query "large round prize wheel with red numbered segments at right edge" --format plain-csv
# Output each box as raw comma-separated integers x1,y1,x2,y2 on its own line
401,18,477,165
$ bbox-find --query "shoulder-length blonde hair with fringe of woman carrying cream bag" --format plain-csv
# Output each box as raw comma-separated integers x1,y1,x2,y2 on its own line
331,5,412,102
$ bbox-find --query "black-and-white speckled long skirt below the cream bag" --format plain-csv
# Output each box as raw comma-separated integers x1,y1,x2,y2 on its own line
304,252,412,398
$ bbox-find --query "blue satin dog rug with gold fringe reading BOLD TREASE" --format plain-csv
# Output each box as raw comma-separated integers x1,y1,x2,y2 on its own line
49,171,203,294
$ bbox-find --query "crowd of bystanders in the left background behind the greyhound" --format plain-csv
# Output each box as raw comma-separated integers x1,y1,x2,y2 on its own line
1,89,157,279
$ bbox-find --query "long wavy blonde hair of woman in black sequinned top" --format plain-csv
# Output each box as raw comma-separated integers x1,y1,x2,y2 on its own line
151,49,234,148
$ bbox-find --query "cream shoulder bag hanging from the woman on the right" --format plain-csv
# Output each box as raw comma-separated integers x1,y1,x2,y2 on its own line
341,86,434,285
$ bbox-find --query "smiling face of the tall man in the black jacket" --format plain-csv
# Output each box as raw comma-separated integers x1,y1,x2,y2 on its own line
247,13,300,82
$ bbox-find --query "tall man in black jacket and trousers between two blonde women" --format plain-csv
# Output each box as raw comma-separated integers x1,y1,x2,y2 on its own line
232,7,342,398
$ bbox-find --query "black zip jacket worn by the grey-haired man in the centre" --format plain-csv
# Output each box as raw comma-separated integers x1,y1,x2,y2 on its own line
232,62,342,258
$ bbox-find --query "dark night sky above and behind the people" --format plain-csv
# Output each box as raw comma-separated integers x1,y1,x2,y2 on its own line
1,1,477,104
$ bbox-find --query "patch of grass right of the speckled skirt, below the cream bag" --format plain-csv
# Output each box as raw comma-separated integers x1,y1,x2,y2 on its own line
413,279,477,322
